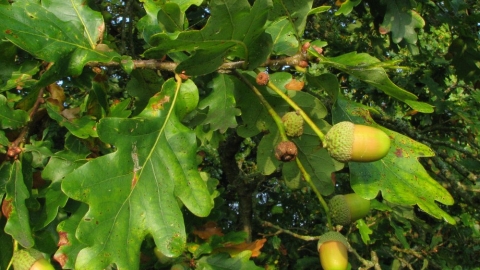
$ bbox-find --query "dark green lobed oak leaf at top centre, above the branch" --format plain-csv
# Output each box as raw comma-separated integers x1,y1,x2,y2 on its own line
145,0,271,75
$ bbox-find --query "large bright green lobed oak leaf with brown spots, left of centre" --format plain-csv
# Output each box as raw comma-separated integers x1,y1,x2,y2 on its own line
62,79,213,269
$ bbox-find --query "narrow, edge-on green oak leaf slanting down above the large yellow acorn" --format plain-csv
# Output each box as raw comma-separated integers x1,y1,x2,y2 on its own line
309,50,433,113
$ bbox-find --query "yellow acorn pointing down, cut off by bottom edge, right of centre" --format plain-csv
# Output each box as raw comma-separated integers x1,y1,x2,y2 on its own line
317,231,348,270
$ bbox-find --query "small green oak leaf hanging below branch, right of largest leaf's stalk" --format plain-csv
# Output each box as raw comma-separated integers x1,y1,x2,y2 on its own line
198,74,240,133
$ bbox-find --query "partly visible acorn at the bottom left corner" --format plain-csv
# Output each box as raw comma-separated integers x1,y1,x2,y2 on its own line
13,249,55,270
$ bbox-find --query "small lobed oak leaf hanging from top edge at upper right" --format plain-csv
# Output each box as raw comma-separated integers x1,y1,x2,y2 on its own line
379,0,425,44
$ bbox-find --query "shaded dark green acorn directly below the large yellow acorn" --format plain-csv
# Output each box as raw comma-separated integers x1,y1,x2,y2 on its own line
328,193,370,225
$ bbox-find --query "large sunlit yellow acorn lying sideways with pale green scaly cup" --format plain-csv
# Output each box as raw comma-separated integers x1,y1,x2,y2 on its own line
325,121,390,162
